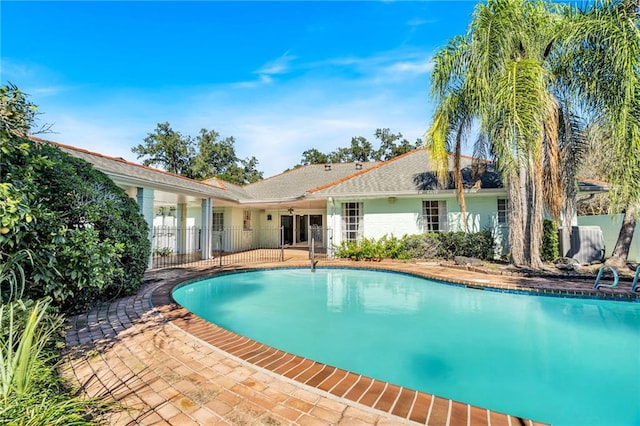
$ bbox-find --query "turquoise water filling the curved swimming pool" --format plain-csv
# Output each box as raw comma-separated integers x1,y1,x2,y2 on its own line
173,269,640,425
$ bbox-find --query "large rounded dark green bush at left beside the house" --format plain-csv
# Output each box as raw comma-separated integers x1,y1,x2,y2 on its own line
0,85,150,311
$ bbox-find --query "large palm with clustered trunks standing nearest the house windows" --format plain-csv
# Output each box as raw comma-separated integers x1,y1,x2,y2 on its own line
426,0,581,268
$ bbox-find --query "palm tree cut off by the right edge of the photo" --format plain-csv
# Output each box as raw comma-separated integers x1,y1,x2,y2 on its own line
568,0,640,267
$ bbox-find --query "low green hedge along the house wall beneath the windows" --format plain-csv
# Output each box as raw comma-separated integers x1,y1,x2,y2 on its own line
335,231,495,260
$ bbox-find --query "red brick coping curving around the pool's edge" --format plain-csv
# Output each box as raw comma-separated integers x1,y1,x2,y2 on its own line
151,261,640,426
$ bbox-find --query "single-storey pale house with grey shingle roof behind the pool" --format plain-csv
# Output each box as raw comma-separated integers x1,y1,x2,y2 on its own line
40,140,606,266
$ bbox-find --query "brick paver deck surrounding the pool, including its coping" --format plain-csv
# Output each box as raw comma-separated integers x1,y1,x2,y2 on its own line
60,251,640,426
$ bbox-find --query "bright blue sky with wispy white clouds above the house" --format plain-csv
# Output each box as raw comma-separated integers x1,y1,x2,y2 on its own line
0,1,475,177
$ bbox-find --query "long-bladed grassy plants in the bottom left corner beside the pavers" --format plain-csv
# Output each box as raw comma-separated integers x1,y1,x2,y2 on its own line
0,251,106,426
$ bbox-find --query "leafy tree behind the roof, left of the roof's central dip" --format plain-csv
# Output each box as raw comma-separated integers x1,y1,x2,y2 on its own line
131,122,262,185
